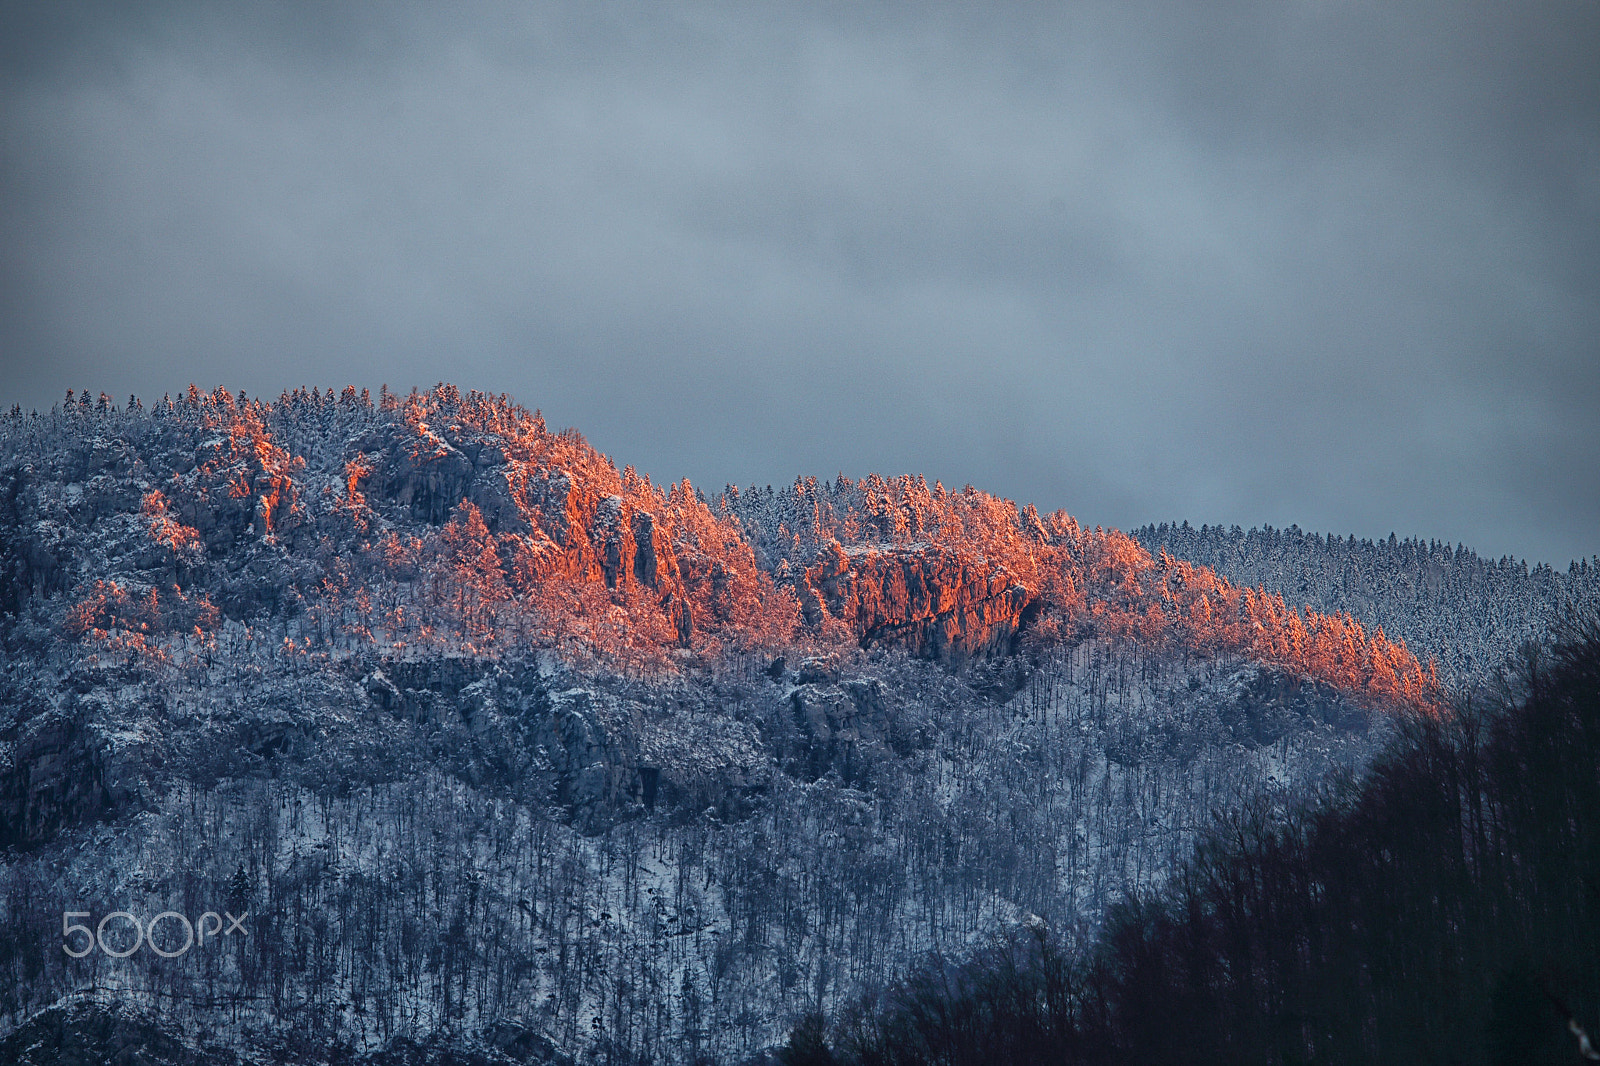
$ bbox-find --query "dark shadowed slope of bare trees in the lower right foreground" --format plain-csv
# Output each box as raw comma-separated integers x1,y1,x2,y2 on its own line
800,624,1600,1066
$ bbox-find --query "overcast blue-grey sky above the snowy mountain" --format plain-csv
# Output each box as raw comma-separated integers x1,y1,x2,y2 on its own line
0,0,1600,568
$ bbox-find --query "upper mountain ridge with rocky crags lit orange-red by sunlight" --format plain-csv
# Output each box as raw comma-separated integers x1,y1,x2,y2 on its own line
0,386,1438,706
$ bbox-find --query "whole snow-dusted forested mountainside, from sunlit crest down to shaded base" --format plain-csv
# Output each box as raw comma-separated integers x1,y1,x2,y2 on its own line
0,386,1600,1063
